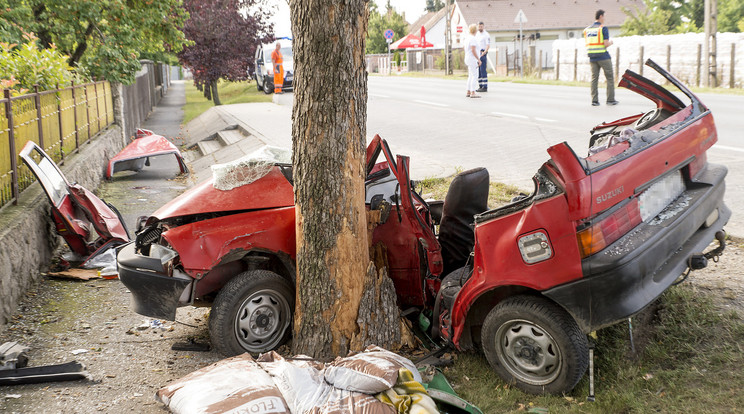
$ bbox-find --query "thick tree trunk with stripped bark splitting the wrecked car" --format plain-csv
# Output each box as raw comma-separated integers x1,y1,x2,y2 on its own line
290,0,380,358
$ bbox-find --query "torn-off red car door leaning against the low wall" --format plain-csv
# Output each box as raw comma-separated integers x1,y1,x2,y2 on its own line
20,141,129,259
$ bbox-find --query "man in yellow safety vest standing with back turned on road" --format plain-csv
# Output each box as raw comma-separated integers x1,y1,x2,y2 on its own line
584,9,619,106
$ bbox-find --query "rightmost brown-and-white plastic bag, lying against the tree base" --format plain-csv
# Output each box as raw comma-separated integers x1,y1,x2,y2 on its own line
325,346,421,394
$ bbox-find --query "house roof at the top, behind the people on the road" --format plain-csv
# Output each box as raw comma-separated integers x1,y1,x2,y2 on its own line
457,0,645,32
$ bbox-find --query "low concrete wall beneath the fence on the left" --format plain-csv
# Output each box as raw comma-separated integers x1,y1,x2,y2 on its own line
0,125,123,331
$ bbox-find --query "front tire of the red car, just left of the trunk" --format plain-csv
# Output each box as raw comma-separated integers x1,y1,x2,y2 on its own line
209,270,295,356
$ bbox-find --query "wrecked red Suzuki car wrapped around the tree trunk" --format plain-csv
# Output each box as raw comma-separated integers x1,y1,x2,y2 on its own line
118,61,731,393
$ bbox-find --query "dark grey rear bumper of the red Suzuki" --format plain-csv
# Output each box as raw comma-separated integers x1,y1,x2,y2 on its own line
543,165,731,333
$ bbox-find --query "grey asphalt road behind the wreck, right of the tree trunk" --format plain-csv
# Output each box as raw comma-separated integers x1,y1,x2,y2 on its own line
367,76,744,237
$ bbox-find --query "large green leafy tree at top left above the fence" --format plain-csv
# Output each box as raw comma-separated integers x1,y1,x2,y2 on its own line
0,0,186,84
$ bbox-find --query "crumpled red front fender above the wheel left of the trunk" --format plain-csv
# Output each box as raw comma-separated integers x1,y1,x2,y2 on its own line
163,206,296,279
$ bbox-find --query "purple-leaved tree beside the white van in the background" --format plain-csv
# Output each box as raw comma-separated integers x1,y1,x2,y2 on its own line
178,0,274,105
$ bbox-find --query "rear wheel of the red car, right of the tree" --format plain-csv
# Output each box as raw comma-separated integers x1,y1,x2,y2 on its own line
481,296,589,394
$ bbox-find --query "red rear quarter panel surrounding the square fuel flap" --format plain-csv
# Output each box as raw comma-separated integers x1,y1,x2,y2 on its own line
444,194,582,346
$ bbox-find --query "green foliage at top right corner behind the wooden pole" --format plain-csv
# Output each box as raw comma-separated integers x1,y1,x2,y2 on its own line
621,0,744,36
